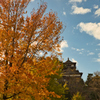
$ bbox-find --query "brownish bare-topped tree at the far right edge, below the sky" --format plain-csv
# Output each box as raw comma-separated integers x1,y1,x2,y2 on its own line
85,71,100,100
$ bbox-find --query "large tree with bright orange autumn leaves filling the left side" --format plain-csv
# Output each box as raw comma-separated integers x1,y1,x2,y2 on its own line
0,0,62,100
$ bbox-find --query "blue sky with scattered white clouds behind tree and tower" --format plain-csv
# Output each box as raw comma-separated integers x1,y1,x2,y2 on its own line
27,0,100,80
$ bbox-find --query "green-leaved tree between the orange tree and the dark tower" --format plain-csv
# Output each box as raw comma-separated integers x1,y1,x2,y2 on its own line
47,60,68,100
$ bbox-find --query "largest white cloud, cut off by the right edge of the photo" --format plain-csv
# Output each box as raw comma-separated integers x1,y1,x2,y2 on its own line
77,22,100,40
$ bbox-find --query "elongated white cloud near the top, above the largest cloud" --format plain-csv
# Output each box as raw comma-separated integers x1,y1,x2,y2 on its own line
72,5,91,14
